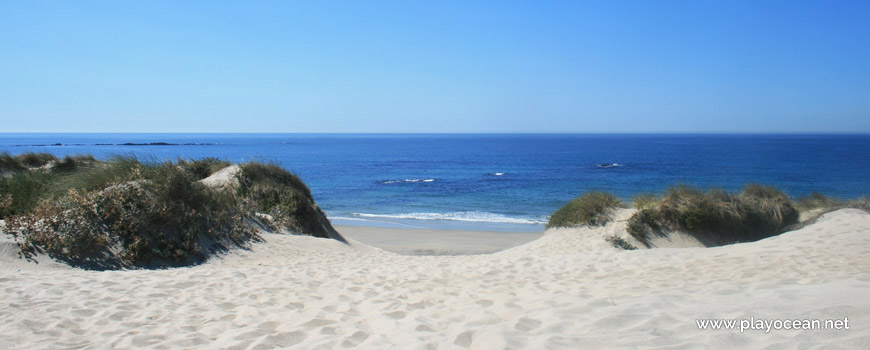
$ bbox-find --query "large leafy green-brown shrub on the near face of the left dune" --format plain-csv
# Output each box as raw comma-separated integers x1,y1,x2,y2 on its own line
10,163,255,267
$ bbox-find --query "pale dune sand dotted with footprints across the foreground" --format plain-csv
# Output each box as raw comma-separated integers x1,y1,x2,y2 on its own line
0,210,870,349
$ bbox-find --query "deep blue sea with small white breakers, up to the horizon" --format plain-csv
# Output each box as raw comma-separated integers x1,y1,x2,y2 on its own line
0,134,870,231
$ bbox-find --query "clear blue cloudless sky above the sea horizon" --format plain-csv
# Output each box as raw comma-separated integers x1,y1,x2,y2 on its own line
0,0,870,132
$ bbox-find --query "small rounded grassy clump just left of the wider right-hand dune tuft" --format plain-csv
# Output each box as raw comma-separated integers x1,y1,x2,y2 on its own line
547,192,622,228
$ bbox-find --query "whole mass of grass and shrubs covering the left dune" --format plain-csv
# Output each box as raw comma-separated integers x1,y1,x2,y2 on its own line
0,152,332,269
